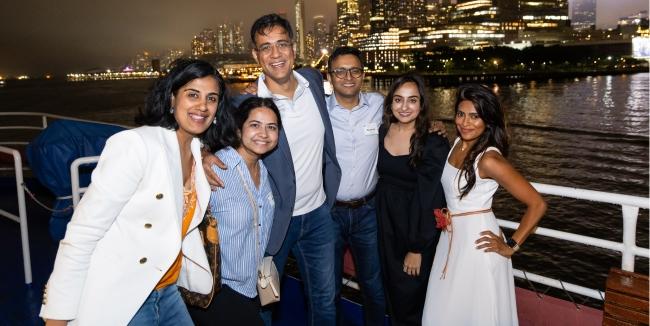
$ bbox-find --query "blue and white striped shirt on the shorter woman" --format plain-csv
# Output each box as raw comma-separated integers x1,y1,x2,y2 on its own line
210,147,275,298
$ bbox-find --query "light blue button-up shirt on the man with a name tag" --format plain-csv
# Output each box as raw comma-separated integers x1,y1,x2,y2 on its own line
327,92,384,201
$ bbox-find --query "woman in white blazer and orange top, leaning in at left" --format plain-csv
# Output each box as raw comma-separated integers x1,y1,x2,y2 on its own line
40,59,225,325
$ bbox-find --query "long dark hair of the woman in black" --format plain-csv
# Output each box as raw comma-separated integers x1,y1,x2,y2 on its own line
383,73,430,168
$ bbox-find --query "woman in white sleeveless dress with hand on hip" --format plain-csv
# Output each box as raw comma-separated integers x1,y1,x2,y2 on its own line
422,84,546,326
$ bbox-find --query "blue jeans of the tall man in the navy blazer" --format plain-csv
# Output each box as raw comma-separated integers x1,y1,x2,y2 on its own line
273,204,336,326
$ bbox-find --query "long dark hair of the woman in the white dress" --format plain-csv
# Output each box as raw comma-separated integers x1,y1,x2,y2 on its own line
454,84,509,199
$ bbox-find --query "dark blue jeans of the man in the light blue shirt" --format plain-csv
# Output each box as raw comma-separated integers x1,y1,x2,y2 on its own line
332,199,386,325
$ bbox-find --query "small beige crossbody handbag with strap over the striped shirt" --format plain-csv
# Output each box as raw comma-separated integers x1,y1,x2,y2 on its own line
237,165,280,306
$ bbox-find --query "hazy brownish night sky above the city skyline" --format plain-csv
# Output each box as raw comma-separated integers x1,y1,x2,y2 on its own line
0,0,648,76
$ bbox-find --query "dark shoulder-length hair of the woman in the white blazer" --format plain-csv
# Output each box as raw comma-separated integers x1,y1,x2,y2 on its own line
135,59,227,143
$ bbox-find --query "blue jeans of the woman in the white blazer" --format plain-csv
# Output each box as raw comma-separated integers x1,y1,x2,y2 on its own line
129,285,194,326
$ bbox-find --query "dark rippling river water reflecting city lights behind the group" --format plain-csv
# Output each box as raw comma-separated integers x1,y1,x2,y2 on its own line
0,73,649,304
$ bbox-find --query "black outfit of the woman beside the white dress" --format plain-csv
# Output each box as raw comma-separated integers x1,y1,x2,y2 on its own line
375,126,449,326
